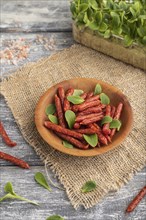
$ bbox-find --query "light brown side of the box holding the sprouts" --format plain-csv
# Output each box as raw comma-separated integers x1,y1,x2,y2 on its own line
73,23,146,70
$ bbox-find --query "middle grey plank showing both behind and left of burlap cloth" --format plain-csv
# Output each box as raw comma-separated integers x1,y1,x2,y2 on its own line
0,33,73,166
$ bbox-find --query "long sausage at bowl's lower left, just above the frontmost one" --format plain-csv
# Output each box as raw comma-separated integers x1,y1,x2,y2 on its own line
44,121,83,140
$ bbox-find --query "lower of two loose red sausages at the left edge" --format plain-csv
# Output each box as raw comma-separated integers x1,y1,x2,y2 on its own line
0,151,29,169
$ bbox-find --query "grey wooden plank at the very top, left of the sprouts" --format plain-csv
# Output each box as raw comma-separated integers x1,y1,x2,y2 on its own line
0,0,72,32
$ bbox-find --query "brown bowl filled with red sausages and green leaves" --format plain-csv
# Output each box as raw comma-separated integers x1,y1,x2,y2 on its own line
35,78,133,156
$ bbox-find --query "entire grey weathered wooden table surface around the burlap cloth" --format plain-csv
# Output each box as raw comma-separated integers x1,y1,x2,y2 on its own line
0,0,146,220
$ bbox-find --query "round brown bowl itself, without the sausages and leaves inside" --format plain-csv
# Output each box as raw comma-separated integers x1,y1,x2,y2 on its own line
35,78,133,157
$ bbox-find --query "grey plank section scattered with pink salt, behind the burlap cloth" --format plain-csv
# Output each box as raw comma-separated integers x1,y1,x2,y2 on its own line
1,32,74,77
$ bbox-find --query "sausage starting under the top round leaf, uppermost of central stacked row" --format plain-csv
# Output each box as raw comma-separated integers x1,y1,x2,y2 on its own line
72,100,100,112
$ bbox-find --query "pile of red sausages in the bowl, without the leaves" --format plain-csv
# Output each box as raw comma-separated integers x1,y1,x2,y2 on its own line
44,87,123,150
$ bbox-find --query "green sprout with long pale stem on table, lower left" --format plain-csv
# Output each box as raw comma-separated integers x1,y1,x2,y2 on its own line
0,182,39,205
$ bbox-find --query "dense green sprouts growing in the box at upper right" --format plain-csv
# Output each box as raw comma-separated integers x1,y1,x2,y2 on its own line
70,0,146,47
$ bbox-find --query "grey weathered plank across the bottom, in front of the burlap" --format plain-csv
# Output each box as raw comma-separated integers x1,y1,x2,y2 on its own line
0,167,146,220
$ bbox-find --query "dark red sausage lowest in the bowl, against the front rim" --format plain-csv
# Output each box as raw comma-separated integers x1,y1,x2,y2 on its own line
57,132,89,150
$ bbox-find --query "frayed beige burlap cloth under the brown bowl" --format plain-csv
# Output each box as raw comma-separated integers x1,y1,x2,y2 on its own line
1,45,146,208
